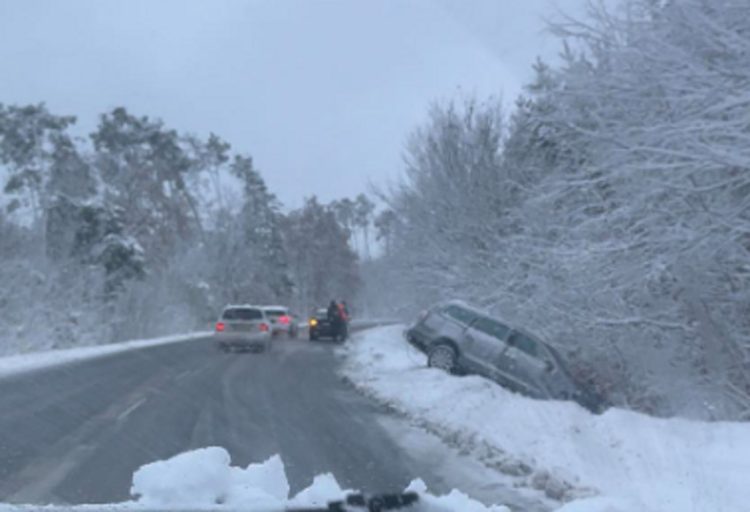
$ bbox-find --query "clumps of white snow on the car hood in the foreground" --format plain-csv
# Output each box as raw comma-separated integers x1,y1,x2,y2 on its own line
125,447,508,512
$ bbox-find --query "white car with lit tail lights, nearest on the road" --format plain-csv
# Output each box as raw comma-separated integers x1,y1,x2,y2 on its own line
214,305,271,351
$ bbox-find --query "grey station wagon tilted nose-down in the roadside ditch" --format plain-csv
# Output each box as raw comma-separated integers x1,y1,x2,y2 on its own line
405,301,603,411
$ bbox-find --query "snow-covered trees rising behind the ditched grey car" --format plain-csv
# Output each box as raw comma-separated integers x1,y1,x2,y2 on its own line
365,0,750,419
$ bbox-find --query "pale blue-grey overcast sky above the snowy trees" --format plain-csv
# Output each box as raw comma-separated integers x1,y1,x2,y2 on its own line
0,0,585,207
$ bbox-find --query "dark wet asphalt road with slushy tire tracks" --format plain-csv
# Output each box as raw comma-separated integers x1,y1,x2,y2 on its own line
0,330,543,509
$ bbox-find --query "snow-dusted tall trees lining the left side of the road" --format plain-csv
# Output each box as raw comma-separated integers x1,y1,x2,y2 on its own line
0,105,366,354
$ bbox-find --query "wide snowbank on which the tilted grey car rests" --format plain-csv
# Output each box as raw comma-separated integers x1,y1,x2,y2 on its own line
344,326,750,512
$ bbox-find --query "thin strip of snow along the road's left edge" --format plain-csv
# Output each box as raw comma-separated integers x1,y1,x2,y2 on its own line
0,332,211,378
